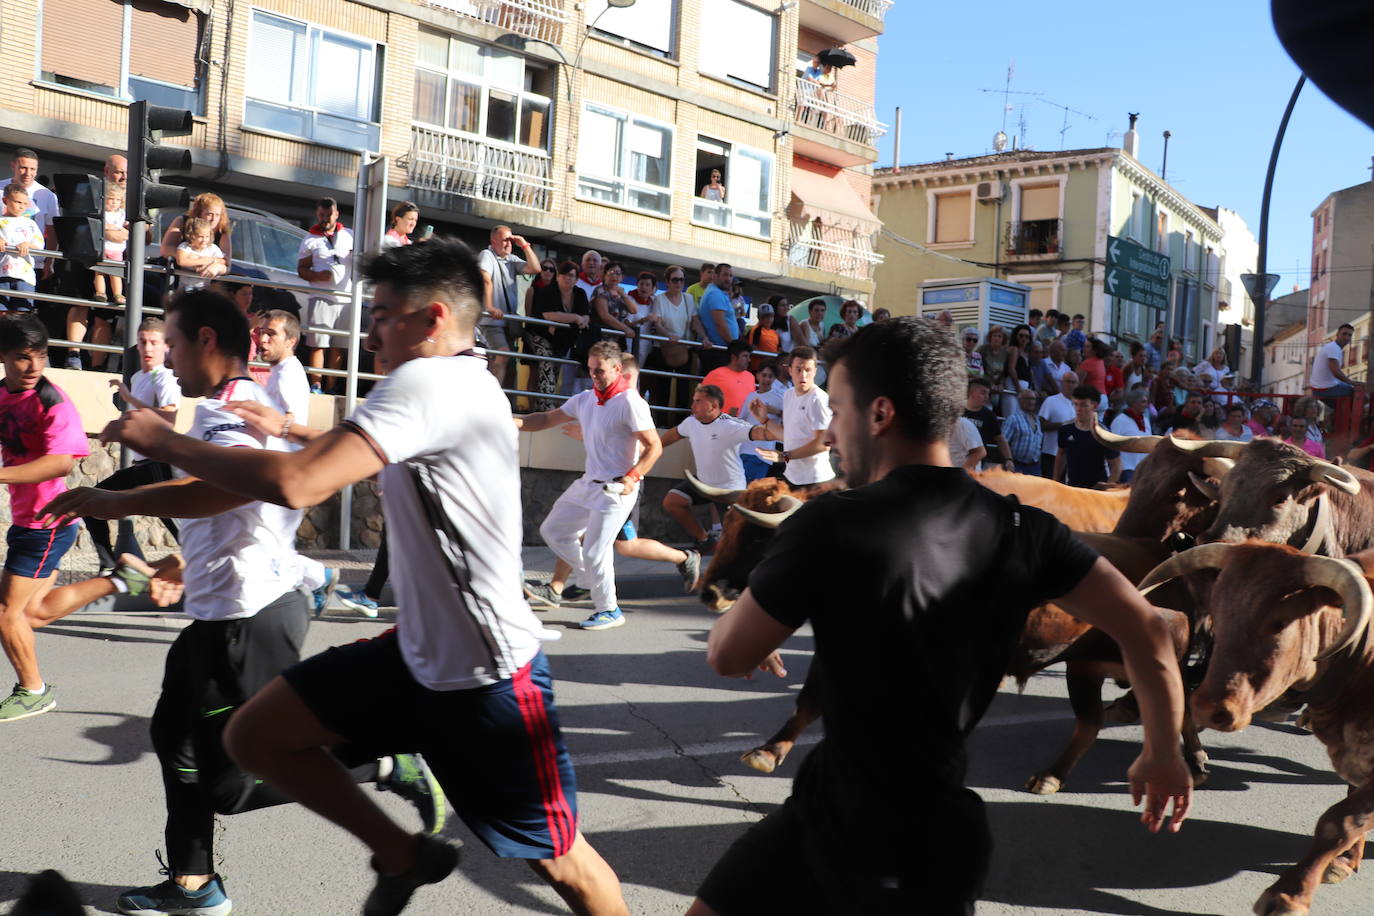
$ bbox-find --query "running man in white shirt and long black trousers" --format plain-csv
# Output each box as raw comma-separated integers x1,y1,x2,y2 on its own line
43,290,442,916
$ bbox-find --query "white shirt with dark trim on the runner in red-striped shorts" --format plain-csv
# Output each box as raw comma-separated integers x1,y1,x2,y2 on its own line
346,356,540,691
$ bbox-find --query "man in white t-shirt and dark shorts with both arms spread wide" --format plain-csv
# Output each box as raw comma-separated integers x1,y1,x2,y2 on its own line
664,385,768,551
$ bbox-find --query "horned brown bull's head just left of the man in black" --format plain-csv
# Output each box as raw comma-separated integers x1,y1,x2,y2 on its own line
687,471,802,612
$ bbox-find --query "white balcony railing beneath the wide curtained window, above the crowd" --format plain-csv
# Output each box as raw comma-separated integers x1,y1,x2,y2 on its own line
405,125,554,210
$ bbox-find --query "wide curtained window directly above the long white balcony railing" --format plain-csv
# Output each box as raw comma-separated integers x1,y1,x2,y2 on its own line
414,29,554,152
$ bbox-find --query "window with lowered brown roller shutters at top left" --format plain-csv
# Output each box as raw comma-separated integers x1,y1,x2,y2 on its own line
40,0,205,114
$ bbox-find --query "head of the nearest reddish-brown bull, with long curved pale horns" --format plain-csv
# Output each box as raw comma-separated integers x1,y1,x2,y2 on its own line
1140,541,1374,732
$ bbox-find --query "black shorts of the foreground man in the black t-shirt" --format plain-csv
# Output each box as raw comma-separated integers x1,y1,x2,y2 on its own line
697,798,974,916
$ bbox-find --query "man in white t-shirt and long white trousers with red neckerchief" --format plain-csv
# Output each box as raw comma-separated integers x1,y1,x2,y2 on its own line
515,341,664,630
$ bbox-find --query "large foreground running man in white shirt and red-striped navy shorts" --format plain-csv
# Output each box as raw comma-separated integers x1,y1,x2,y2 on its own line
80,239,628,915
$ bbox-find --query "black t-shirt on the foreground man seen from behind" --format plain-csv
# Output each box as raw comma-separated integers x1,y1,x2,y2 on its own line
749,464,1096,889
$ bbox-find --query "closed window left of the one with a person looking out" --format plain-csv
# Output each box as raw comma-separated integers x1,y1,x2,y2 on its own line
577,102,673,216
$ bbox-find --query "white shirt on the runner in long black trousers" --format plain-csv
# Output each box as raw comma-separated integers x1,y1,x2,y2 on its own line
174,379,301,621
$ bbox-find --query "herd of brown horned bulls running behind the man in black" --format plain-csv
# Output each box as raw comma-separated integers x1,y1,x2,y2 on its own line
684,427,1374,916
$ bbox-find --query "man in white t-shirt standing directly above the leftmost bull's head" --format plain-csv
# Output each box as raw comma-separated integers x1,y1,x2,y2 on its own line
750,346,835,488
